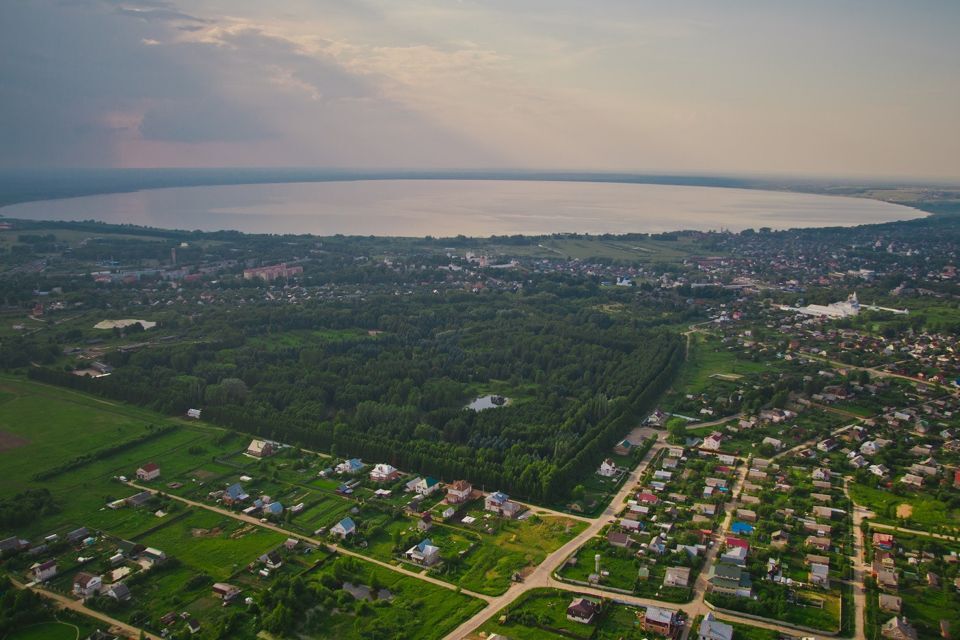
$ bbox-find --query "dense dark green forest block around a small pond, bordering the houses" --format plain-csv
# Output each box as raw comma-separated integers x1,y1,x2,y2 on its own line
22,282,683,500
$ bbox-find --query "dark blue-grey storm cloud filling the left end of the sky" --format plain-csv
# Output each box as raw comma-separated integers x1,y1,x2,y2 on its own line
0,0,269,165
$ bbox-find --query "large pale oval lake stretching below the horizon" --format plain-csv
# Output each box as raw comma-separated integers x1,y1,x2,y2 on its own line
0,180,926,236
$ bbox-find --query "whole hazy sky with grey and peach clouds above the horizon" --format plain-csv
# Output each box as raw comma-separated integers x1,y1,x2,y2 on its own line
0,0,960,180
